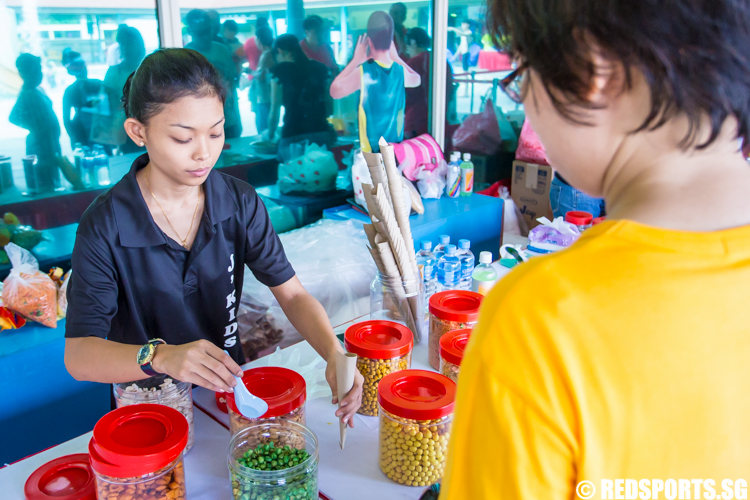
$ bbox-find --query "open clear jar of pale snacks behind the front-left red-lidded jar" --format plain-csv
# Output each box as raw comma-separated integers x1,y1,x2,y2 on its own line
114,375,195,453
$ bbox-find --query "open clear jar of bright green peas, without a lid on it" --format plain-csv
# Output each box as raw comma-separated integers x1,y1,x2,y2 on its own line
227,420,318,500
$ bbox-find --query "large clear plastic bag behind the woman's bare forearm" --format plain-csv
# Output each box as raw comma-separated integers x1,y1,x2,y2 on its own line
238,219,376,357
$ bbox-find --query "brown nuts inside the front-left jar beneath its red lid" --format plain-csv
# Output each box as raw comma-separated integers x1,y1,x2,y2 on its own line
96,457,187,500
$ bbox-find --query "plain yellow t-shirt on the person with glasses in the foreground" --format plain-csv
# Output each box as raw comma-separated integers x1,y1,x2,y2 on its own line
440,221,750,500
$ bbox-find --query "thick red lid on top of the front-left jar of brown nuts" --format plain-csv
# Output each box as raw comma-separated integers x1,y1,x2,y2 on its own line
89,404,188,478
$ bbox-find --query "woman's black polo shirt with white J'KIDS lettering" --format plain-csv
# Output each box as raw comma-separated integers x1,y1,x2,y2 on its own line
65,154,294,363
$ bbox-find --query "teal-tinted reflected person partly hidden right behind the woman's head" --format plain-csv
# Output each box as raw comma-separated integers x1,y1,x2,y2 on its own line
185,9,242,139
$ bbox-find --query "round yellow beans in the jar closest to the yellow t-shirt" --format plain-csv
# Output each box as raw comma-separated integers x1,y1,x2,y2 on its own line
380,408,453,486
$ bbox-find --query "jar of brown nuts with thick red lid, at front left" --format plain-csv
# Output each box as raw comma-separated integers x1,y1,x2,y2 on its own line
89,404,188,500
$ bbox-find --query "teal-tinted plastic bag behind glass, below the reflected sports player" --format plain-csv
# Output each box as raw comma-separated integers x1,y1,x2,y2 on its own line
278,142,339,194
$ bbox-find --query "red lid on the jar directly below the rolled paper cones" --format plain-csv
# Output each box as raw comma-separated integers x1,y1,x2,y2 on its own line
344,320,414,359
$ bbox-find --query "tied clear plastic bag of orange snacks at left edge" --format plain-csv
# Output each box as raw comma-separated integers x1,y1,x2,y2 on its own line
3,243,57,328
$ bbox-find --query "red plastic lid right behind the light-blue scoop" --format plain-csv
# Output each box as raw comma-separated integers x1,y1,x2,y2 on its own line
226,366,307,418
